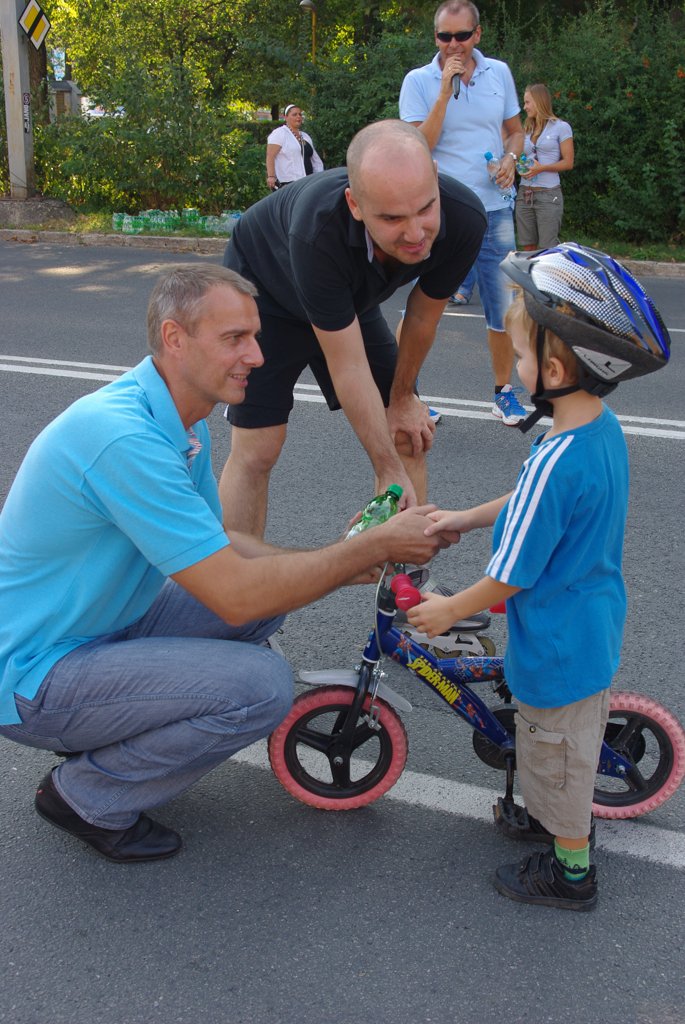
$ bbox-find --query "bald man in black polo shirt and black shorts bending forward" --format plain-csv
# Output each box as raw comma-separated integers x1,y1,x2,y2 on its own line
220,121,486,536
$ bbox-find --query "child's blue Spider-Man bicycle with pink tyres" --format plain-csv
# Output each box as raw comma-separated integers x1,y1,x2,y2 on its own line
268,573,685,818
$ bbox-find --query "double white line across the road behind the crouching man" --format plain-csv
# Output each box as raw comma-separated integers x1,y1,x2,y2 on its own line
0,355,685,440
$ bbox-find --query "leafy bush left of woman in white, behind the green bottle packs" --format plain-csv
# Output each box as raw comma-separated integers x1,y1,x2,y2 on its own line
36,64,264,213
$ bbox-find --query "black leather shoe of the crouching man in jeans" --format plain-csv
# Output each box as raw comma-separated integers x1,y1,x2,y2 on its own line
35,772,182,863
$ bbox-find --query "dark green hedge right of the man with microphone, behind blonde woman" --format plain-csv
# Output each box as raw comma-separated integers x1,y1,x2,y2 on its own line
485,0,685,243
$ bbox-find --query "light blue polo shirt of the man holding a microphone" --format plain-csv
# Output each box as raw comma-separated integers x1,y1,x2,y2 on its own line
399,49,521,212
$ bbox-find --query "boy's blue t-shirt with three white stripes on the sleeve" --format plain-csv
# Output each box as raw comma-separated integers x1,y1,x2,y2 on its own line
486,407,629,708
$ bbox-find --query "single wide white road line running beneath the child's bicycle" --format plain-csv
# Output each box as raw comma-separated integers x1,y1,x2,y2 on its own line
231,740,685,870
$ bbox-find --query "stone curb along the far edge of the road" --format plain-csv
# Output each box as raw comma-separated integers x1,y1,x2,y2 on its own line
0,227,685,278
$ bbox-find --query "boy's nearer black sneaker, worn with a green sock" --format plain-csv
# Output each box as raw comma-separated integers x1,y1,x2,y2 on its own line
495,850,597,910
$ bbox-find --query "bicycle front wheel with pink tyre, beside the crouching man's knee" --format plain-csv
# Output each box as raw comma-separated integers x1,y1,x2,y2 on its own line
268,686,408,811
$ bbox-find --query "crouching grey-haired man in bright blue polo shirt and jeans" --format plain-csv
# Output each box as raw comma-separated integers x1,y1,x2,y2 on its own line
0,264,438,861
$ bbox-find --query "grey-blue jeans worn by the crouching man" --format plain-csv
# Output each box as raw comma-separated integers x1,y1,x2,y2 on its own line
0,580,293,828
